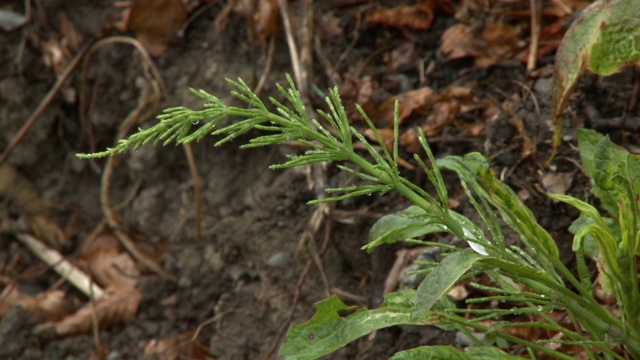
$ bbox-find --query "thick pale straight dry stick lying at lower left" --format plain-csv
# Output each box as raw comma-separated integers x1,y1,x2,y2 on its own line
16,234,106,299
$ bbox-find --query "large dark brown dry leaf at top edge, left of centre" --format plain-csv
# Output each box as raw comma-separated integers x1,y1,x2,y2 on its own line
126,0,187,56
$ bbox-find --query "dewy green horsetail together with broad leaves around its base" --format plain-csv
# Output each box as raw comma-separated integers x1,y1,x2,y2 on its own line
79,74,640,359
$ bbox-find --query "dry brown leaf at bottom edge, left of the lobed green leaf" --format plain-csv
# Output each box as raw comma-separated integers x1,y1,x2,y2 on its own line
144,331,213,360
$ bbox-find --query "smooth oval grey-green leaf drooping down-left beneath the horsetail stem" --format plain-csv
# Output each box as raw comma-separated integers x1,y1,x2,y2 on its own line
411,250,483,319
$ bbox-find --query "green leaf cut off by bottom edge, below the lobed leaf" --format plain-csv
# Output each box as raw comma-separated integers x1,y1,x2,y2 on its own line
390,346,523,360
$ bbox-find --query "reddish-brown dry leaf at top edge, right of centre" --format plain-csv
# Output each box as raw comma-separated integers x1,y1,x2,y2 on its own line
367,1,435,30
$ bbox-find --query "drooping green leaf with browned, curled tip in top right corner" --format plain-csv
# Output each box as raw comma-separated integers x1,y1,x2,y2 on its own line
552,0,640,155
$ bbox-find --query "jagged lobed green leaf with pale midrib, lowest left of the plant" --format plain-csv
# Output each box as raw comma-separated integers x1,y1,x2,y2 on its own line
279,289,441,360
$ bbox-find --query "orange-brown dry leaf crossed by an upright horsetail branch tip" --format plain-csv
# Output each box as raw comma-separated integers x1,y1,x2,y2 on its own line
376,87,433,128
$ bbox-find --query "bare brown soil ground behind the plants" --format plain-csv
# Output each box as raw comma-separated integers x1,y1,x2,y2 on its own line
0,0,638,360
